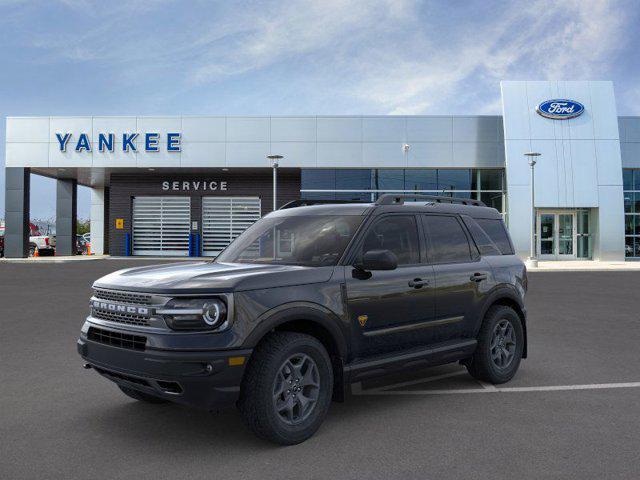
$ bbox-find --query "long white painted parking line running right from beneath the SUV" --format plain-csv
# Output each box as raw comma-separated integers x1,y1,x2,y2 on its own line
354,382,640,395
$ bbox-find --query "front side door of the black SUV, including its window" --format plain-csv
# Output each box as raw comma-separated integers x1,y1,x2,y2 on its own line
345,214,435,356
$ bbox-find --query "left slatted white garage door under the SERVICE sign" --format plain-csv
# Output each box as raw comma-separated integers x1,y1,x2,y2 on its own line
133,197,191,256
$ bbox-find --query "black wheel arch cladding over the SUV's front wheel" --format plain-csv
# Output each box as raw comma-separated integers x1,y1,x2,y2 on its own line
247,306,348,401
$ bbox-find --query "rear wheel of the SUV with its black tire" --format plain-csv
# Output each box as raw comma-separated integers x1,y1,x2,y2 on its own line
466,305,524,384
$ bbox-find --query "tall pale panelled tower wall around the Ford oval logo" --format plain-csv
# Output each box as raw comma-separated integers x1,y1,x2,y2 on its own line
501,81,624,260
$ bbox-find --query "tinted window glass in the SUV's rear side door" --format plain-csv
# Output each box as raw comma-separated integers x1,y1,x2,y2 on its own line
422,215,471,263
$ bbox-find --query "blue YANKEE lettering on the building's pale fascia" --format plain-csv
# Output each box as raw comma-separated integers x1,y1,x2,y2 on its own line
56,132,181,153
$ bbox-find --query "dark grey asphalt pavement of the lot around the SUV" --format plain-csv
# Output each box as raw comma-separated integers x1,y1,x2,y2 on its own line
0,260,640,479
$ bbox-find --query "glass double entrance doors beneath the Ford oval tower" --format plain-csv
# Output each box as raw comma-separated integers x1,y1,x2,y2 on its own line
536,210,577,260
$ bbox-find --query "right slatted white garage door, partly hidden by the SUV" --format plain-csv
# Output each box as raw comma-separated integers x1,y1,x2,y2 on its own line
202,197,260,257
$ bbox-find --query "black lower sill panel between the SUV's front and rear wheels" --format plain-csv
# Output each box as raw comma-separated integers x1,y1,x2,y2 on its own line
344,338,478,383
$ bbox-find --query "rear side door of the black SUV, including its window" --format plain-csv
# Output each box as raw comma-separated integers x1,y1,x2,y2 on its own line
422,215,492,341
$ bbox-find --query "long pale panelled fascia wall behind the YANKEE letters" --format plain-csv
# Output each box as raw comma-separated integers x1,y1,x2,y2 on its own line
6,116,504,168
